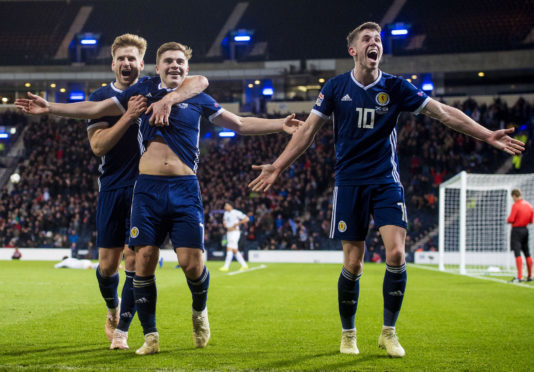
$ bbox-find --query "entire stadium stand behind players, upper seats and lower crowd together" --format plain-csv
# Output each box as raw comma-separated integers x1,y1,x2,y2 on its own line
0,0,534,260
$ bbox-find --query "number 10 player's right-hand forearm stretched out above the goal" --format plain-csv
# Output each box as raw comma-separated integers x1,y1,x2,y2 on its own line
421,99,525,155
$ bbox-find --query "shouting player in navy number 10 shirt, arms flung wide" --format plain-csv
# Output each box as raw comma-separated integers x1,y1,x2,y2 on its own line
249,22,524,357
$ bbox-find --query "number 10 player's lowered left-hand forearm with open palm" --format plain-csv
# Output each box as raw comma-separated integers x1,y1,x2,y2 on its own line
248,113,325,191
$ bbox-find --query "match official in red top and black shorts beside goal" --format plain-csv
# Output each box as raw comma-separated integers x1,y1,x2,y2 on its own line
507,189,534,283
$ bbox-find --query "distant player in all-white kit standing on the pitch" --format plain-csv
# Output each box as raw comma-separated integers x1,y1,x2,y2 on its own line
220,202,249,271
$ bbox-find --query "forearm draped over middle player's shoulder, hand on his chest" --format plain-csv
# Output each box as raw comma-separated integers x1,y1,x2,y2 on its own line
146,75,209,125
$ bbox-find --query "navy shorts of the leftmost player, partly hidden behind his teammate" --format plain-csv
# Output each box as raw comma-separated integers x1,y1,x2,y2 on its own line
96,186,133,248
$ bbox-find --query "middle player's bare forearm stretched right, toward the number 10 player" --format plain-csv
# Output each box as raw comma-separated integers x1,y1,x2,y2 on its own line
213,111,304,135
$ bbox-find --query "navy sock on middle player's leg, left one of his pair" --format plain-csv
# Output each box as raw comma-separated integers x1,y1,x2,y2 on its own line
133,275,158,335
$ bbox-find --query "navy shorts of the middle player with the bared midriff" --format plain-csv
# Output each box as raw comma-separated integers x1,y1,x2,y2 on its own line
130,174,204,250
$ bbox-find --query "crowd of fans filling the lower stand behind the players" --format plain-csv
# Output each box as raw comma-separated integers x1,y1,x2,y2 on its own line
0,99,534,261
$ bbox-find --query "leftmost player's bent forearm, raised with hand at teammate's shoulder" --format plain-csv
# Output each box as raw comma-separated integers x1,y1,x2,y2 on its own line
87,96,146,156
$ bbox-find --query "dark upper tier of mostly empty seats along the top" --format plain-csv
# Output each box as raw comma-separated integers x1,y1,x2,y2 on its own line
0,0,534,65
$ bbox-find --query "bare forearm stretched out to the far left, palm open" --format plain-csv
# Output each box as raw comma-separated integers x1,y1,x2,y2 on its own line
15,92,122,119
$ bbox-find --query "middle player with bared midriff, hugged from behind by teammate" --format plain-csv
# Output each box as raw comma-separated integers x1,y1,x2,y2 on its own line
106,42,302,355
